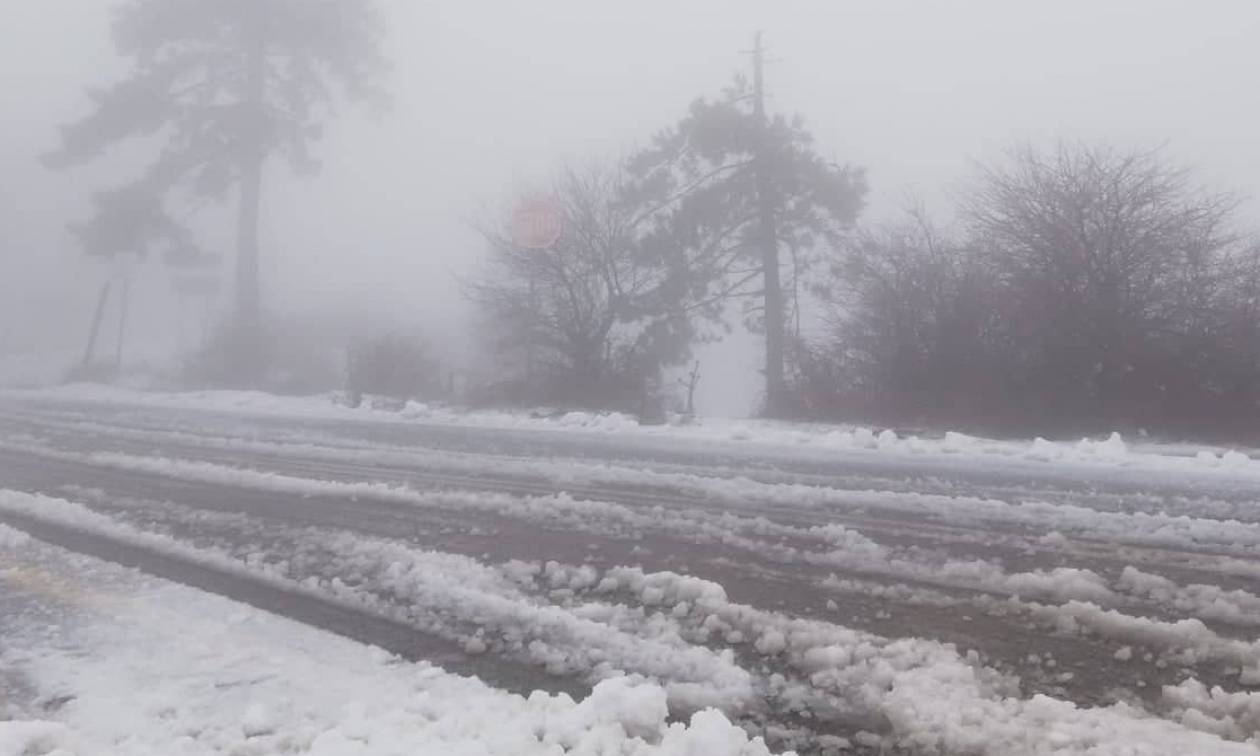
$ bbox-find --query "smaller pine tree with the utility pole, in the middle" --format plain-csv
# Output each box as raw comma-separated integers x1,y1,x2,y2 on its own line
631,65,866,416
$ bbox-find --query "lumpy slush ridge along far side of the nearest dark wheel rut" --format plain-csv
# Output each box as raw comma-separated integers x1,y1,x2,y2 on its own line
0,490,753,711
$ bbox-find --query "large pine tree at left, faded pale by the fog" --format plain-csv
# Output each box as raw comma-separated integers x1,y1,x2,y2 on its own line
47,0,383,382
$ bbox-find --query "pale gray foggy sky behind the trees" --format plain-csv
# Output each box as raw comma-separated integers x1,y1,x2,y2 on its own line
0,0,1260,408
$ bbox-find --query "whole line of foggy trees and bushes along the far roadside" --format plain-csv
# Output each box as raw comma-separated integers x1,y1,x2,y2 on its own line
56,0,1260,437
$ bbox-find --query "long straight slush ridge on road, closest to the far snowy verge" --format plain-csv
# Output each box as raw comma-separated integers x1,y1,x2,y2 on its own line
9,408,1260,577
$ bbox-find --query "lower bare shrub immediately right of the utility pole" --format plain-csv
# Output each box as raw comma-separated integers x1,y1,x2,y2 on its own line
795,205,1000,422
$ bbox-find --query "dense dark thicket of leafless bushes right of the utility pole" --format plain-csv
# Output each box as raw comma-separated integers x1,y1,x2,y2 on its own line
796,145,1260,437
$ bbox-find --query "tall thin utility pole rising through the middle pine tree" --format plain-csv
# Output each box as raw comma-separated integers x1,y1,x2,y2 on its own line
752,32,786,417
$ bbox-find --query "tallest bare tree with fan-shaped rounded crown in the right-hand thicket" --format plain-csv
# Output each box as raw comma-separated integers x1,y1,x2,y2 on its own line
963,142,1236,407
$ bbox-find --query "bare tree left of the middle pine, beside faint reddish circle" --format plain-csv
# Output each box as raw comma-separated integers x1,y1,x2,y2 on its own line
466,166,660,402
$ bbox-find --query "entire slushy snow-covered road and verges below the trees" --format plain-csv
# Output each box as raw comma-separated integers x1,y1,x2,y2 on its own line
0,387,1260,756
